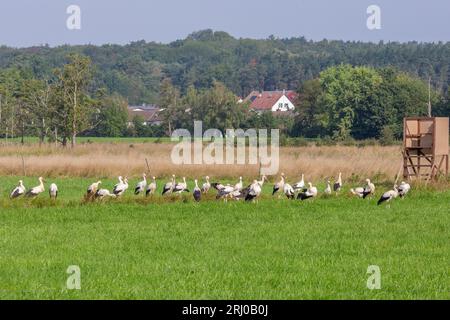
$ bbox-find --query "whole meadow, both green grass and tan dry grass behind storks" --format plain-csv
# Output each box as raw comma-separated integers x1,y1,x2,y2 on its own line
0,142,450,299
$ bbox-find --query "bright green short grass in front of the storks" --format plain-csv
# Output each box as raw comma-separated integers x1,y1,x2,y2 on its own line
0,177,450,299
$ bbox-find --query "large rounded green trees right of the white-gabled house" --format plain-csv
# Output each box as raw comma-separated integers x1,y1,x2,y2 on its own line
291,65,450,140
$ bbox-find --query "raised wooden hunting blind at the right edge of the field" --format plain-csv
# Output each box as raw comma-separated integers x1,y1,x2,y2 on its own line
403,117,449,180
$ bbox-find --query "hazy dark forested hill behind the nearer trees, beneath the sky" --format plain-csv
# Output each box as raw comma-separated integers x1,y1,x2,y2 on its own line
0,30,450,104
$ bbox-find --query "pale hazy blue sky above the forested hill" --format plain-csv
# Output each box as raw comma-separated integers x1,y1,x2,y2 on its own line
0,0,450,47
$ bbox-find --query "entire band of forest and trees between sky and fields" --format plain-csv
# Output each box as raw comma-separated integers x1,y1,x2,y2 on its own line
0,30,450,146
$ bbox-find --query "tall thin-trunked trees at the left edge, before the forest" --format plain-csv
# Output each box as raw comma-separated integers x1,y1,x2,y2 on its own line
0,54,96,146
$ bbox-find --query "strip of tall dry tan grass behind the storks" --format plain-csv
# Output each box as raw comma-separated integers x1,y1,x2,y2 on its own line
0,143,402,181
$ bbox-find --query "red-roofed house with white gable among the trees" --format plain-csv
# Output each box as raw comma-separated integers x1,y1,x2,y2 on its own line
243,90,297,112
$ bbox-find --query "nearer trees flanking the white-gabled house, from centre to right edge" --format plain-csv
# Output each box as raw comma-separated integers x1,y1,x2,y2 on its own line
156,64,450,141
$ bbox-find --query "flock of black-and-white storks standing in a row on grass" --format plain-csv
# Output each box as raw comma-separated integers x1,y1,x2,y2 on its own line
10,173,411,205
